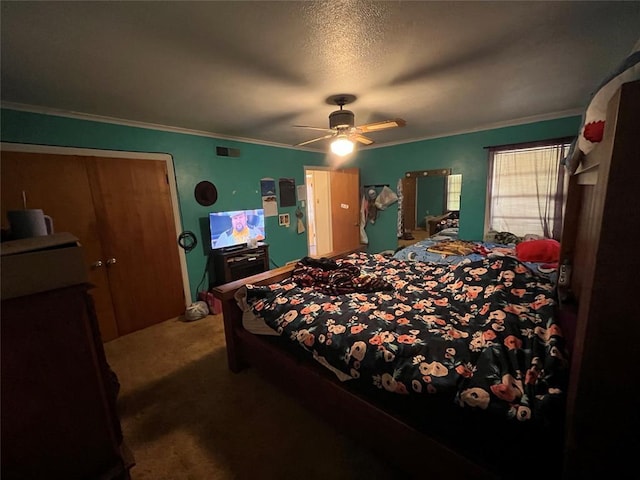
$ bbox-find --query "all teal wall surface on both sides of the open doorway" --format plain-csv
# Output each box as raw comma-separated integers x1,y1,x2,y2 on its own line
1,109,580,299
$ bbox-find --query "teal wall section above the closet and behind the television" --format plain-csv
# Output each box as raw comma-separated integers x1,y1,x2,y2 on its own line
1,109,325,300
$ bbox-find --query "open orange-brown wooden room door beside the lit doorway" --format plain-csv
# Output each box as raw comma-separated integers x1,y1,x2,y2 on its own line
331,168,360,252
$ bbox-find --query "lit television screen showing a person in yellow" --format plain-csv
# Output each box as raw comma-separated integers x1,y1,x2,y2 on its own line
209,208,265,248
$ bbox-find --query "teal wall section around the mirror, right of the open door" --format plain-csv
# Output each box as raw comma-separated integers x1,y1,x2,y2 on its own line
351,116,580,252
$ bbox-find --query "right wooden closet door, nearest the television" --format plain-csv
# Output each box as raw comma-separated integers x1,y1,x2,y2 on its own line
88,157,185,335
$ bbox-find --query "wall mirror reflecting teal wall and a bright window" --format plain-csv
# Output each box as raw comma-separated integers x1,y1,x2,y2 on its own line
398,168,462,246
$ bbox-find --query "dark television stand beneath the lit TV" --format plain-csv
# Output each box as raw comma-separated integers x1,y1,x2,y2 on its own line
209,243,269,287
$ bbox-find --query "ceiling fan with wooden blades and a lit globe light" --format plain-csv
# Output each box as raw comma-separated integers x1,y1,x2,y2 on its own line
294,94,407,155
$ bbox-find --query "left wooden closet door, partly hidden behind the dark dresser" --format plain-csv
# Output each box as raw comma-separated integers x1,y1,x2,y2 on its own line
0,151,119,342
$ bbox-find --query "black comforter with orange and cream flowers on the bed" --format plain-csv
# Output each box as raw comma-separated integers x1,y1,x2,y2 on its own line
242,253,568,421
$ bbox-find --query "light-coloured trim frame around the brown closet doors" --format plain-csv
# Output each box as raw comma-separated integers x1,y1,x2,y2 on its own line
0,142,191,305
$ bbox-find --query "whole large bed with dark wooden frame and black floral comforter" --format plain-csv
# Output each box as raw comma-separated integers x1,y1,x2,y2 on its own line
214,81,640,478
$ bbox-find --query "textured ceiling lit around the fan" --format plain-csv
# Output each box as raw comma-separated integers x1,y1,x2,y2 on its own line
1,1,640,149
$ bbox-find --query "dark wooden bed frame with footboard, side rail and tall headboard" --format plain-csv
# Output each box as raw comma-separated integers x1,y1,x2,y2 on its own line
213,81,640,479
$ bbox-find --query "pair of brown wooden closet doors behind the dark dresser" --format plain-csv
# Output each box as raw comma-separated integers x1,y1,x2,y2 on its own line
1,151,185,342
